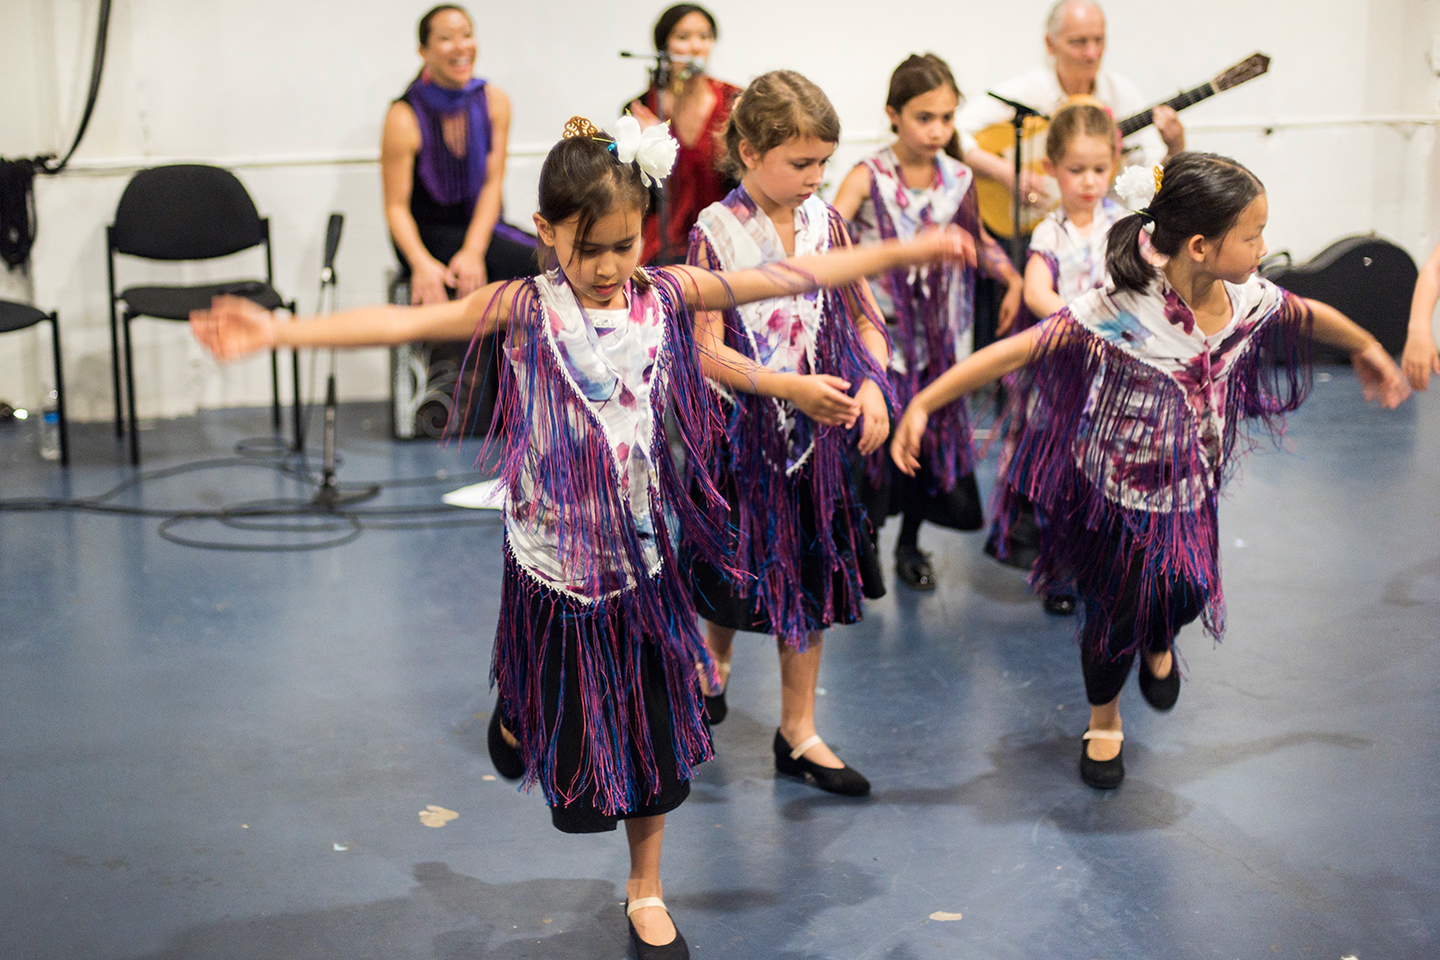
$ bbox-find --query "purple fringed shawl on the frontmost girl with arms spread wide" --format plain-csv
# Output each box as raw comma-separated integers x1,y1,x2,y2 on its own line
488,271,726,815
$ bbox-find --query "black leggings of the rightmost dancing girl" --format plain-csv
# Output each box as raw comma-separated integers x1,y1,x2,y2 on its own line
1080,551,1205,707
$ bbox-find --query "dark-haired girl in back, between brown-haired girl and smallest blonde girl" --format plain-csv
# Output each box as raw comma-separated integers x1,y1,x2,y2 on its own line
835,53,1022,590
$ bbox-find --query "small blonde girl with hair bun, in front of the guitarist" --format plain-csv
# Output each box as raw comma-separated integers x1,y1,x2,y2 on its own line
985,102,1125,616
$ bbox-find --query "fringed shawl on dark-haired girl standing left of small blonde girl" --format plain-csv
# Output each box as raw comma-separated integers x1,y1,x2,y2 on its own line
857,148,981,495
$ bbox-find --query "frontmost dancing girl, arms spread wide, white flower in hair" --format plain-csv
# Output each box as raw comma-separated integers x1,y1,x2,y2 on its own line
192,118,973,959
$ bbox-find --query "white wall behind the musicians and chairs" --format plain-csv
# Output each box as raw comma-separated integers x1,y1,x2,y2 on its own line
0,0,1440,419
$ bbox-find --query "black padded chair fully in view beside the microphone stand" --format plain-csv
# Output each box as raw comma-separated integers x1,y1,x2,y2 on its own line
105,164,302,466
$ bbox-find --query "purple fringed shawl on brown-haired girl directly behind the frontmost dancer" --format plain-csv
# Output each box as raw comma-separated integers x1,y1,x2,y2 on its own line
688,187,894,649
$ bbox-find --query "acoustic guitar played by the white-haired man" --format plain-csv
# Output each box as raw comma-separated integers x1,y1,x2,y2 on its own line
975,53,1270,237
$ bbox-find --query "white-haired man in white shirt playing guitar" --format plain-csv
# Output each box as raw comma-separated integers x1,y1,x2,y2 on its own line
955,0,1185,211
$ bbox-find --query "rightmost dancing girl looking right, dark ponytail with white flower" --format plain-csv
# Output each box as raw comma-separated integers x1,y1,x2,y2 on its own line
891,153,1410,789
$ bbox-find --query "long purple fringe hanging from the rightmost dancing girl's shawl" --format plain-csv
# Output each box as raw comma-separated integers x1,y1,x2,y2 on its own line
1001,298,1310,649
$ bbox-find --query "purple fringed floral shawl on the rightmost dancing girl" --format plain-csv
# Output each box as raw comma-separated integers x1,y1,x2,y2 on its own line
999,279,1310,651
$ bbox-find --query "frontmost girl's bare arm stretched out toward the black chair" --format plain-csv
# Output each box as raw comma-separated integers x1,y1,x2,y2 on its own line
190,281,517,361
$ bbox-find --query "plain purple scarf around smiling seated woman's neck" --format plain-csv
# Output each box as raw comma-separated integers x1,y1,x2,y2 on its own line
403,72,490,209
